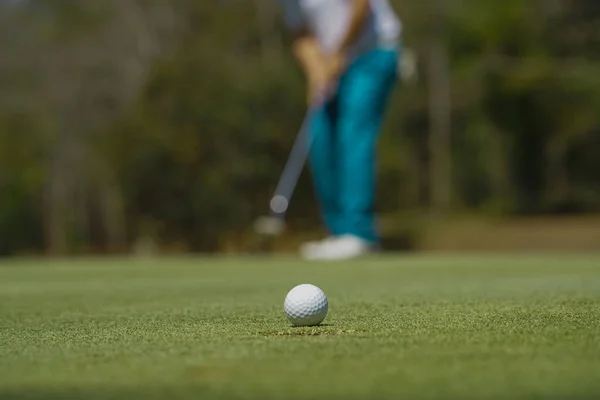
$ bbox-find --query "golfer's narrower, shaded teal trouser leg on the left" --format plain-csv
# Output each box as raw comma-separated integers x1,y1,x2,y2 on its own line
309,104,340,235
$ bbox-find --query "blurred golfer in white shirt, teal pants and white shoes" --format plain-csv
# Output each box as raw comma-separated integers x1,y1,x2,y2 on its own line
279,0,401,260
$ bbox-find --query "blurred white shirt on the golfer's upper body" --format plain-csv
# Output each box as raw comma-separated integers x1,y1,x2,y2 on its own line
279,0,402,53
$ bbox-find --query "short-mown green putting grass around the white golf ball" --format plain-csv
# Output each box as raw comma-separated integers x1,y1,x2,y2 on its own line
0,256,600,400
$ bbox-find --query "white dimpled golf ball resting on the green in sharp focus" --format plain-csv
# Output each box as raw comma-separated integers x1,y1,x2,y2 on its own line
283,284,329,326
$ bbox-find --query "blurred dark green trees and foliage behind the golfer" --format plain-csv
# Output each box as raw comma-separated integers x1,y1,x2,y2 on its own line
0,0,600,255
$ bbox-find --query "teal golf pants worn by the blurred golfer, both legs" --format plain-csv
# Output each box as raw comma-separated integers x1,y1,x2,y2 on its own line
309,45,398,242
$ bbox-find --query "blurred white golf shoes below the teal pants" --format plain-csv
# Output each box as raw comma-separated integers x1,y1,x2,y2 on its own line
301,235,379,260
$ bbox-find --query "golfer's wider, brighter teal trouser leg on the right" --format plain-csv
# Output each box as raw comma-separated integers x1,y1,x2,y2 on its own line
336,50,398,242
